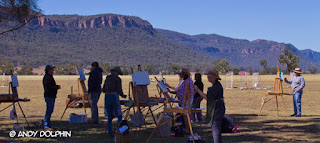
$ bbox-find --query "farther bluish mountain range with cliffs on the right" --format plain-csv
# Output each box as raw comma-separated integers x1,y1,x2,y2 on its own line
157,29,320,69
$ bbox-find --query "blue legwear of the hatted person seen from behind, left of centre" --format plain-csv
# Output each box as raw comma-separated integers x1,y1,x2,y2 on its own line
105,95,122,135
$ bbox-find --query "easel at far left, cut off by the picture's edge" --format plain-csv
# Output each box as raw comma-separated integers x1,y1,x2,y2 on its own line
0,75,30,127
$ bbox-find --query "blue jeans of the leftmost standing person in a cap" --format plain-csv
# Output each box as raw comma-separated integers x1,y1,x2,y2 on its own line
44,97,56,128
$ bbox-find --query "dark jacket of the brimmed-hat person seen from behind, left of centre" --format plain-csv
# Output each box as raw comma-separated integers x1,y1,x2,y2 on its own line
103,72,123,96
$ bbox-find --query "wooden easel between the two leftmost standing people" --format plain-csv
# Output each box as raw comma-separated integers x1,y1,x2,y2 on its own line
60,69,90,120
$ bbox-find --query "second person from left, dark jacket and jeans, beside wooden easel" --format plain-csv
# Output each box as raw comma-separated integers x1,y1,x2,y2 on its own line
88,62,103,124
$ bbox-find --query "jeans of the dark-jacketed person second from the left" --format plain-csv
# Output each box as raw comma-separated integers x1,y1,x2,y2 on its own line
90,92,100,122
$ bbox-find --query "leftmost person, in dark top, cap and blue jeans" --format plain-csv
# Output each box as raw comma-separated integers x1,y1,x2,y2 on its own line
42,65,61,130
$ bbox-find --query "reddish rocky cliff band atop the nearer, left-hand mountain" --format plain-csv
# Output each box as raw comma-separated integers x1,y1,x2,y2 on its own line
28,14,153,31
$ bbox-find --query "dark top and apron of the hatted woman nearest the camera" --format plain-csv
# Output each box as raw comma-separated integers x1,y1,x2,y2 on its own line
206,81,226,124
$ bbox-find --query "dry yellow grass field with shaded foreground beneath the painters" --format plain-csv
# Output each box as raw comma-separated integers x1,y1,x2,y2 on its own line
0,75,320,143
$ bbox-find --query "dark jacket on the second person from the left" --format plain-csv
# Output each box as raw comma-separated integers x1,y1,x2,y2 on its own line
88,67,103,93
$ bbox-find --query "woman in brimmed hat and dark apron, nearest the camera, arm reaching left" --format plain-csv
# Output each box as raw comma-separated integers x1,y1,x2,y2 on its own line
195,69,226,143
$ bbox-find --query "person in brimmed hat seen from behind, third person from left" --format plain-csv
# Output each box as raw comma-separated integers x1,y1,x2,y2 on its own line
102,66,126,136
